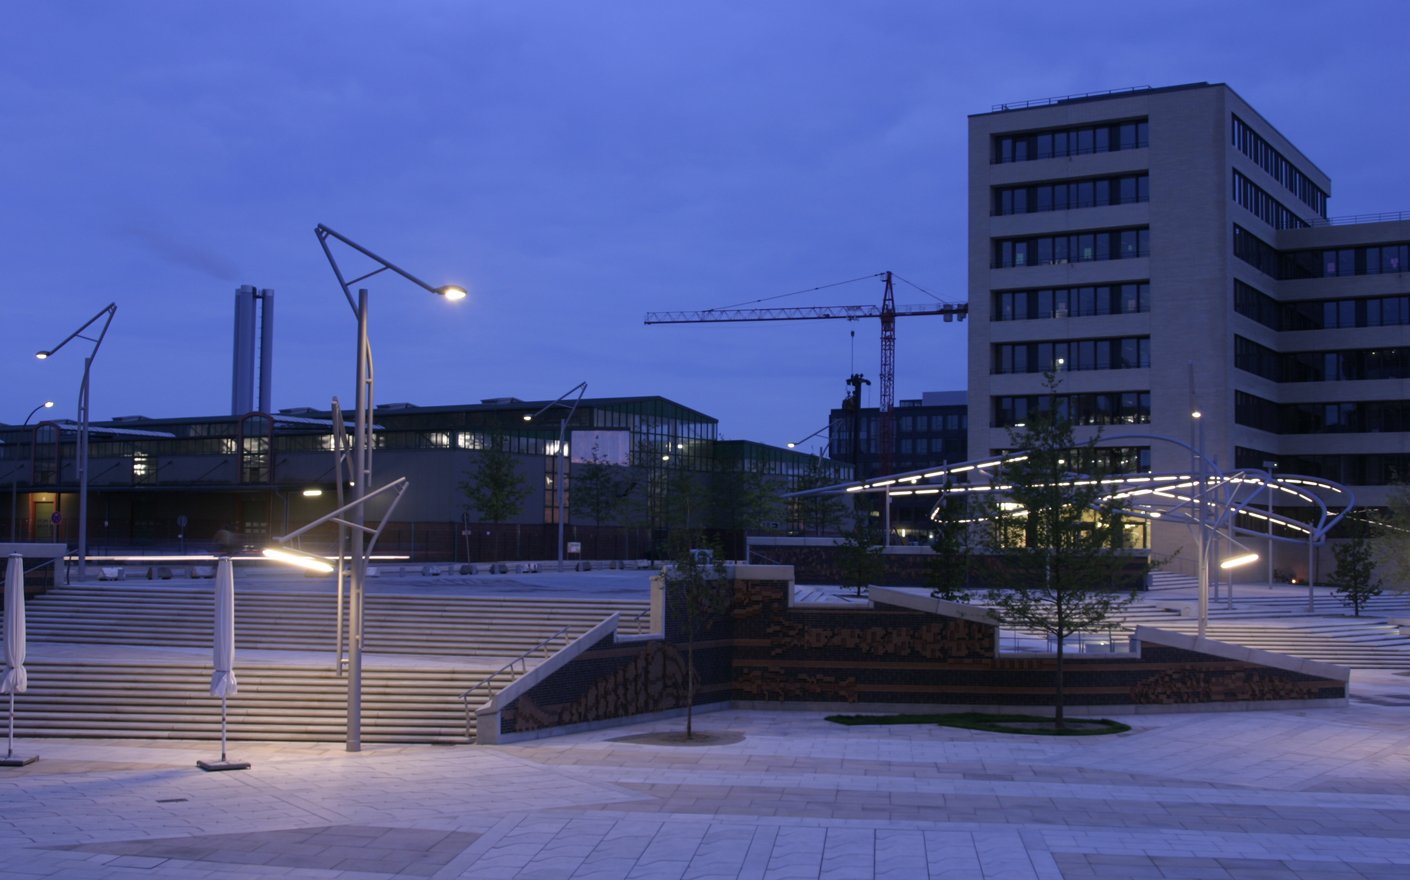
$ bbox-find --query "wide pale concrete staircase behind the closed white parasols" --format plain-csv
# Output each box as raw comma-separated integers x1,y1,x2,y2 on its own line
0,585,647,743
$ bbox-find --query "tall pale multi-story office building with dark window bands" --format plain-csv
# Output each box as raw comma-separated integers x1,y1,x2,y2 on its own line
969,83,1410,567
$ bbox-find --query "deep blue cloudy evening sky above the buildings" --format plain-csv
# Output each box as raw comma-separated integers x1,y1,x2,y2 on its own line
0,0,1410,446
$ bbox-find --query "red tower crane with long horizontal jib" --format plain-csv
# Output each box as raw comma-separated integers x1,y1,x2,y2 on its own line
646,272,969,478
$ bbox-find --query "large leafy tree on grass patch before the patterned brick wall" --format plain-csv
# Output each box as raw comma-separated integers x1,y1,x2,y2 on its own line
986,374,1152,728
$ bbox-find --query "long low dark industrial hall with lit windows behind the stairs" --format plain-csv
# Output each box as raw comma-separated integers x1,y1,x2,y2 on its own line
0,396,852,557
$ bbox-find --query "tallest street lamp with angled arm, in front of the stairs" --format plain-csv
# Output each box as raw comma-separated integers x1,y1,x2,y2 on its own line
314,223,465,752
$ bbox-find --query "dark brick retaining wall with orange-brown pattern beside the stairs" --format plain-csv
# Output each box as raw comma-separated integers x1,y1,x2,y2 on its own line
501,581,1347,733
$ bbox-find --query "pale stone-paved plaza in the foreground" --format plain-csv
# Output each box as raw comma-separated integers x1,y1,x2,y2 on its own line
8,671,1410,880
